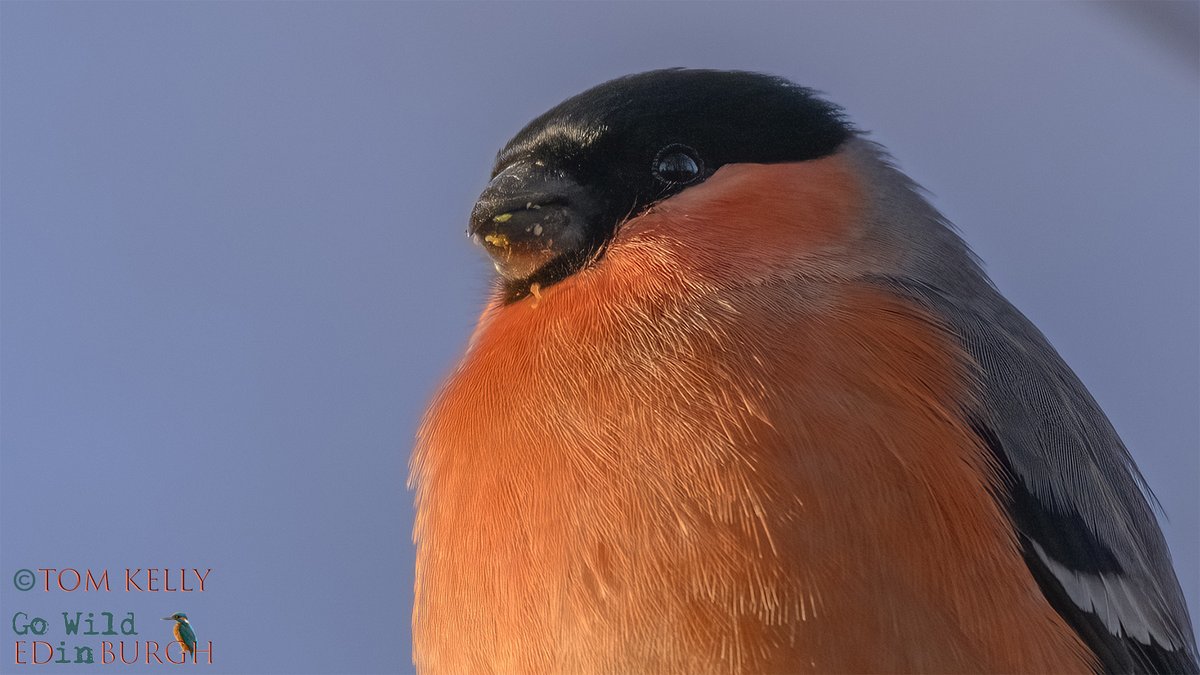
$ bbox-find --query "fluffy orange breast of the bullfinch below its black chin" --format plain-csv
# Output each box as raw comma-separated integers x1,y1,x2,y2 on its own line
413,154,1090,673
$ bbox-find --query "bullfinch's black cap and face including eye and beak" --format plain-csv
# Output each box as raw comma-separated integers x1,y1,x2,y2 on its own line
469,70,853,301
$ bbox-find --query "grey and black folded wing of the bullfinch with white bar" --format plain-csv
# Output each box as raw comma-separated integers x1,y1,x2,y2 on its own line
888,280,1200,673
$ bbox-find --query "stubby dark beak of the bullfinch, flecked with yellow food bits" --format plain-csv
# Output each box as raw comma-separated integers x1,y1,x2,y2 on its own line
468,161,599,282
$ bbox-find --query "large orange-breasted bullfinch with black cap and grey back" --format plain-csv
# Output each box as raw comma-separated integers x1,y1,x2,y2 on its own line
409,68,1196,673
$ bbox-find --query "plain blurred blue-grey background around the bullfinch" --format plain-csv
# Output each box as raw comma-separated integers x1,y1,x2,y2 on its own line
0,1,1200,673
